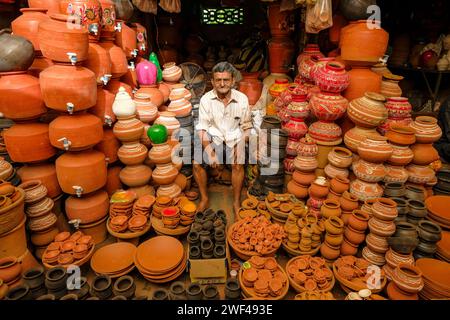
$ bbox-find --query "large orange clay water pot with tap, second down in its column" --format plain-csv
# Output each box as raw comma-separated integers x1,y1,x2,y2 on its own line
39,65,97,113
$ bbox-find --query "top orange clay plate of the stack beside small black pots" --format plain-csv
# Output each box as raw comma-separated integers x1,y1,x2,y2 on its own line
136,236,184,273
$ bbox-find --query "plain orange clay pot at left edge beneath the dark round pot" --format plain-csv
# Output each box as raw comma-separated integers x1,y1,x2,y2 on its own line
0,71,47,121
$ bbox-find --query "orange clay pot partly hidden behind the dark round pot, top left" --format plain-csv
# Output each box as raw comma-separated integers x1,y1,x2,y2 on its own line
11,8,50,51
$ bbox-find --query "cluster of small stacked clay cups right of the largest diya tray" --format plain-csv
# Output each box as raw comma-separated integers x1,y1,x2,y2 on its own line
282,207,325,256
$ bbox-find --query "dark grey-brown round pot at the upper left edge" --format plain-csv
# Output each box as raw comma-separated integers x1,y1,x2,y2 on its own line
0,29,35,72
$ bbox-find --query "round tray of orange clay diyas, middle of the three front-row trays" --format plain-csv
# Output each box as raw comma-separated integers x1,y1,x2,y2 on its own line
286,255,335,293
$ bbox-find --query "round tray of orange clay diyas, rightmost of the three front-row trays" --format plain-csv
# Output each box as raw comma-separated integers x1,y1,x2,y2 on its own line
333,256,387,293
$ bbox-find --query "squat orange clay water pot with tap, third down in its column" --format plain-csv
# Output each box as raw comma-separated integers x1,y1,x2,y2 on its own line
49,114,103,151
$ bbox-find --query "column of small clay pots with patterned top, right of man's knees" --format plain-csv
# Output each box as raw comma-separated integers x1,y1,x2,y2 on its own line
286,134,318,199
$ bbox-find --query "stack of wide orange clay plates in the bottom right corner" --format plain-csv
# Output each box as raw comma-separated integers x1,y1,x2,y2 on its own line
416,258,450,300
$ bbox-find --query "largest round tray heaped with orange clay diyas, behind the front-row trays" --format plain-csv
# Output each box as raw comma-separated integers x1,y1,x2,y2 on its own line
227,216,286,260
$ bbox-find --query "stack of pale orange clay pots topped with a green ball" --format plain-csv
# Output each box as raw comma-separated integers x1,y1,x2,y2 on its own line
147,124,181,198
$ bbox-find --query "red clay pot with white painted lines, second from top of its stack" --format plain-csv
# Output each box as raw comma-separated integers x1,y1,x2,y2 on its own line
309,92,349,121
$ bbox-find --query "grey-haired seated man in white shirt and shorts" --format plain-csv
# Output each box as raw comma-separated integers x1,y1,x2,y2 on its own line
193,62,252,219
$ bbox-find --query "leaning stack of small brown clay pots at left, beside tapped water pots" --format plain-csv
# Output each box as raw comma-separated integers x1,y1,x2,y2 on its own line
19,180,59,257
